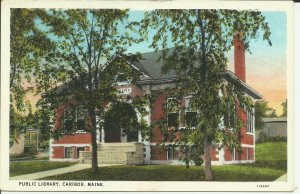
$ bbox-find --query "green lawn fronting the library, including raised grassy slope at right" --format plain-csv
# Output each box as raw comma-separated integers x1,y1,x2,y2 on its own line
39,142,286,181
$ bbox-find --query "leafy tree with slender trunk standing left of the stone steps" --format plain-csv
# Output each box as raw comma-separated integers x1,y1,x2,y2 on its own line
37,9,144,173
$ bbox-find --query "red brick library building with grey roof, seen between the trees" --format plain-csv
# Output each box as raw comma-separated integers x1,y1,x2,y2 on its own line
50,37,262,165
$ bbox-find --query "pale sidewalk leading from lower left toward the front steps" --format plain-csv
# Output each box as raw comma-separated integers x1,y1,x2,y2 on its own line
10,164,115,180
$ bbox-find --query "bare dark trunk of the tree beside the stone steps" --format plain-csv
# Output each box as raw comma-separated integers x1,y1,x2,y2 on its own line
90,109,98,173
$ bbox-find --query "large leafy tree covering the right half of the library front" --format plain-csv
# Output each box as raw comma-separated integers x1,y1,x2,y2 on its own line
142,9,271,180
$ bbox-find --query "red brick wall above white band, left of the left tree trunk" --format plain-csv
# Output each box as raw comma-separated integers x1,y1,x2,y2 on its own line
53,133,91,144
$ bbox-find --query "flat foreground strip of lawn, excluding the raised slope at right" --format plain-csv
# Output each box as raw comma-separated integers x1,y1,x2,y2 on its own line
43,165,285,181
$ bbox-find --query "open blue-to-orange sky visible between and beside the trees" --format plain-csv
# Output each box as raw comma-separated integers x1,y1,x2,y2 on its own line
24,11,287,115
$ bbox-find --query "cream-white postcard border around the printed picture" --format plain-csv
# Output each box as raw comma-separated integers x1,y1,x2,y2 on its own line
0,0,295,191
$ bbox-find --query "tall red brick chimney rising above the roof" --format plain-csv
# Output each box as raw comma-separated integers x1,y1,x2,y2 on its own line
233,34,246,82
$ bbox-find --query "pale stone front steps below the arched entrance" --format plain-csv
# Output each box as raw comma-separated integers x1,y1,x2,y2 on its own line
79,142,144,165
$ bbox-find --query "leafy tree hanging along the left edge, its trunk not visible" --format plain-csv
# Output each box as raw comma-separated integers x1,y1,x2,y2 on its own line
10,9,54,146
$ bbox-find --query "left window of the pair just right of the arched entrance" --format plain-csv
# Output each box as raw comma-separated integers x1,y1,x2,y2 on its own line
167,98,179,127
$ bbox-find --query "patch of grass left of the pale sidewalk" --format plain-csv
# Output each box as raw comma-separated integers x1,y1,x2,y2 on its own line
9,160,75,177
